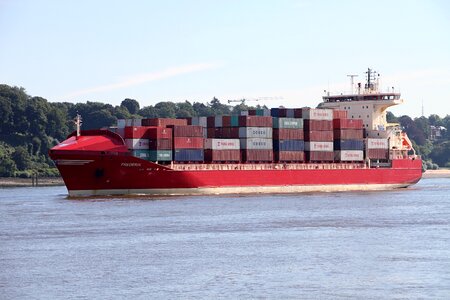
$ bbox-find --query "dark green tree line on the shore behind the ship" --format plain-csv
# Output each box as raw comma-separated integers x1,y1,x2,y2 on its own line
0,84,450,177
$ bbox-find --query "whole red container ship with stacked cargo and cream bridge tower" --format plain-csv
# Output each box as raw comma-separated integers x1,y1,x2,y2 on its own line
49,69,422,197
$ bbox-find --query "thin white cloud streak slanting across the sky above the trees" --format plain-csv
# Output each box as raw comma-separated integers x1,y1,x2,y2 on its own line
63,63,221,99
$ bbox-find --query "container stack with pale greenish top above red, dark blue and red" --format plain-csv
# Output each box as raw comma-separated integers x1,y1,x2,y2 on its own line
273,117,305,162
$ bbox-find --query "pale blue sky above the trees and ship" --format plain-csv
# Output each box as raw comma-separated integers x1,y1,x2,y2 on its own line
0,0,450,117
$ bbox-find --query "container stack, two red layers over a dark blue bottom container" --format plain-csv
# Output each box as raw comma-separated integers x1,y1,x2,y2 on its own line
171,125,204,162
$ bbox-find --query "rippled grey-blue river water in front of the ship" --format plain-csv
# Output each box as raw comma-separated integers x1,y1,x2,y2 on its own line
0,178,450,299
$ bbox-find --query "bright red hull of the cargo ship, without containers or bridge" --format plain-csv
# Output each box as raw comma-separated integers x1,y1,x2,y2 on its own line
50,132,422,195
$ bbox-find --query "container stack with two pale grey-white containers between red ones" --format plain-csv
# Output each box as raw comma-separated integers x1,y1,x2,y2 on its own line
238,116,273,162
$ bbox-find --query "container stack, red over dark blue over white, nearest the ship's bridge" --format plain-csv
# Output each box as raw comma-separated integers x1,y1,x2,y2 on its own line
333,117,364,161
